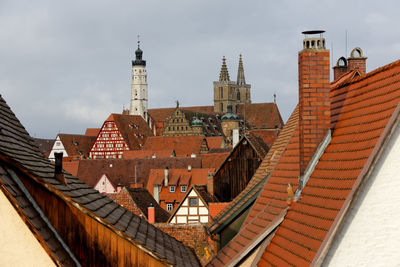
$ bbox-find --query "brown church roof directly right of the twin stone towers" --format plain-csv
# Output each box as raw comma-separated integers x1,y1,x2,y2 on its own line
237,103,283,129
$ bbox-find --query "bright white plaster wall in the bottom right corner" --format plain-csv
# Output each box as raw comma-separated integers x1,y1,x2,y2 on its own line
323,122,400,266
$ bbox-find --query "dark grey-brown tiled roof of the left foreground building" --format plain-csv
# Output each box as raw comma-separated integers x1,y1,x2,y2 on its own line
0,96,200,266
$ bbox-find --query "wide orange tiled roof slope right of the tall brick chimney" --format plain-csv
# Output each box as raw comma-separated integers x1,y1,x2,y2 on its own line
262,61,400,265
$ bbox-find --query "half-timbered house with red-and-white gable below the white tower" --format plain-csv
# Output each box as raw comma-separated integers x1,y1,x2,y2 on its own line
90,114,153,159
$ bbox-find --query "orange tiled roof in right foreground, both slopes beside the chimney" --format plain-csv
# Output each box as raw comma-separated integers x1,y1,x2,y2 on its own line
211,58,400,266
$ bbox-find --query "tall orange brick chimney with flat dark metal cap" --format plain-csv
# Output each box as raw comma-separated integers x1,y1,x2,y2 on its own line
299,31,331,177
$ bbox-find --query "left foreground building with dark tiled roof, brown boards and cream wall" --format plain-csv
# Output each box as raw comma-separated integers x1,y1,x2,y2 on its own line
0,96,200,266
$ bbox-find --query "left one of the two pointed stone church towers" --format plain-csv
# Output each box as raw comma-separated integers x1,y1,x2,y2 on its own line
214,57,237,113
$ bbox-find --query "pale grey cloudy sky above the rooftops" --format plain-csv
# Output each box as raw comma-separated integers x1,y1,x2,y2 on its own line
0,0,400,139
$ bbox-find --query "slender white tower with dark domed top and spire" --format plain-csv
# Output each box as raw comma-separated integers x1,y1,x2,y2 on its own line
129,41,148,121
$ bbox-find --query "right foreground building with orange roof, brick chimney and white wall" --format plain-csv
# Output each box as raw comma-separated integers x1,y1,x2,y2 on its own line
208,31,400,266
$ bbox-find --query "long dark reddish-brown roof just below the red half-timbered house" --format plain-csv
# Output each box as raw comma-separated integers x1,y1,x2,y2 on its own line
77,158,201,187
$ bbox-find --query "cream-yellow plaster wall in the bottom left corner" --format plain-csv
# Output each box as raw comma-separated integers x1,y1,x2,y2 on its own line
0,190,56,267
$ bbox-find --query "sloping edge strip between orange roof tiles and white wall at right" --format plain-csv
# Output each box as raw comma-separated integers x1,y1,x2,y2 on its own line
311,103,400,266
